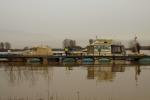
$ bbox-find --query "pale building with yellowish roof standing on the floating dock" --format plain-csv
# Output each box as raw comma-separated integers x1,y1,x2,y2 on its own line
87,39,125,56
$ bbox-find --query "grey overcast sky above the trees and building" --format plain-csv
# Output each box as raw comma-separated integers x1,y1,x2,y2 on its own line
0,0,150,48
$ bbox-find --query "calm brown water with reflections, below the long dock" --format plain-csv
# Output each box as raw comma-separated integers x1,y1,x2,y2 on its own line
0,63,150,100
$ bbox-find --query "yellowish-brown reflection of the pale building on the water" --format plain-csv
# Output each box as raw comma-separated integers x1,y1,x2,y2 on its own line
87,65,125,81
